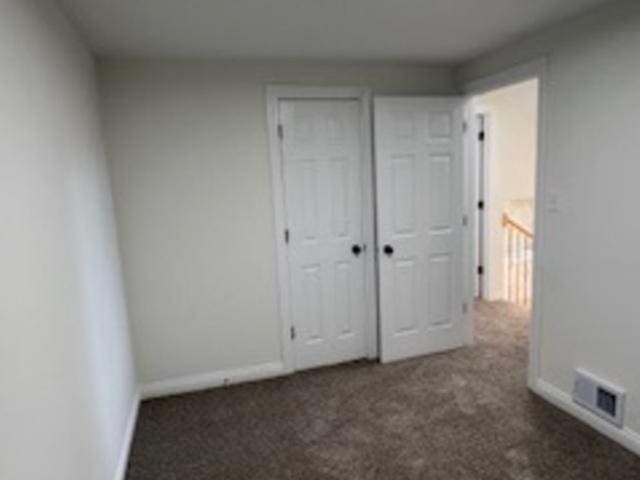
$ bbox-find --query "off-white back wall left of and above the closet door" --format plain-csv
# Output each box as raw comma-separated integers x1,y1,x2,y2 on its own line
100,60,452,390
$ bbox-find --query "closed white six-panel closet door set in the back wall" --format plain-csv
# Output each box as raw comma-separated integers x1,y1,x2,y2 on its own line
279,99,367,370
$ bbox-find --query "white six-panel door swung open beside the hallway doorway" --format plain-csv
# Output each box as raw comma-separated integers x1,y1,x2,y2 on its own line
375,98,465,362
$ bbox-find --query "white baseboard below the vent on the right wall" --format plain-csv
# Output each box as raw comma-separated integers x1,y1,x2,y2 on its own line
531,378,640,455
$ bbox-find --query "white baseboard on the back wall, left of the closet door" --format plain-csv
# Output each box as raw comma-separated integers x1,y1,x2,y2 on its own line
140,362,288,400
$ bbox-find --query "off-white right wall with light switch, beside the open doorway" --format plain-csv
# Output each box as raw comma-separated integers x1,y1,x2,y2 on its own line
459,1,640,446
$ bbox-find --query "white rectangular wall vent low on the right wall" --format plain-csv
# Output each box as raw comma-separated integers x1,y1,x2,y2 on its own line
573,369,627,427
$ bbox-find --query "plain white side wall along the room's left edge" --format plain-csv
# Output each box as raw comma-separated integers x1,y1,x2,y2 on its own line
0,0,135,480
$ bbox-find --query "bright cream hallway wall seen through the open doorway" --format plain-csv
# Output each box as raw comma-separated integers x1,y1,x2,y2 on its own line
474,80,538,300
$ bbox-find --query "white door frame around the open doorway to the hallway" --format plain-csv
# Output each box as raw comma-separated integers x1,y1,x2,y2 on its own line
463,57,549,390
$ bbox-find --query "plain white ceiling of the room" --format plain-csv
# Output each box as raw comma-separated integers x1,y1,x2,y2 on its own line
60,0,609,63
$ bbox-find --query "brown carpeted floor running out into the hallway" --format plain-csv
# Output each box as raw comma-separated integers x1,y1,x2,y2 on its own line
127,304,640,480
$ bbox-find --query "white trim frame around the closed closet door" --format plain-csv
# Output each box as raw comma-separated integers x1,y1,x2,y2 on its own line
266,85,378,374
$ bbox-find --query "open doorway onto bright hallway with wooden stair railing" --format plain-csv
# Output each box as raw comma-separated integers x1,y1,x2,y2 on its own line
470,76,541,385
